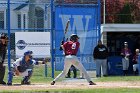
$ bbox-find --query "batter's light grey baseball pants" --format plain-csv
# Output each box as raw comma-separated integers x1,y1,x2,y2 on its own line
54,55,91,82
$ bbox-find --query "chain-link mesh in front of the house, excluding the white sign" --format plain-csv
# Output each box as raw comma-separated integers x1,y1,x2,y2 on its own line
0,0,51,62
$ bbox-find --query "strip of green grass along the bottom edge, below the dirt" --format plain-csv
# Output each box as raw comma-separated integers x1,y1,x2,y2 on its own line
0,88,140,93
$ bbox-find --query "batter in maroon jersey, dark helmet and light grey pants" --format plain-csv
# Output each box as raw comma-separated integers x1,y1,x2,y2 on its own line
51,34,96,85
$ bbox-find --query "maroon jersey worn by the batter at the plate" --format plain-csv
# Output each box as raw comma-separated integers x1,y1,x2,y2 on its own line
63,41,80,55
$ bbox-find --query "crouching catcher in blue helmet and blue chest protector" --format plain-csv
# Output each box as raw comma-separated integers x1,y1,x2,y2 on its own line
7,51,36,85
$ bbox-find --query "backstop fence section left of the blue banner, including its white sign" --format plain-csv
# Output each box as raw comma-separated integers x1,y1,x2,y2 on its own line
0,0,51,78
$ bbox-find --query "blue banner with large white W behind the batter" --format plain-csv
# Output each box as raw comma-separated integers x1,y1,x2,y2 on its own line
54,0,100,70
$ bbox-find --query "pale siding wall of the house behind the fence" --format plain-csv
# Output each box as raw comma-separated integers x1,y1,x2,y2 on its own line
0,0,50,32
